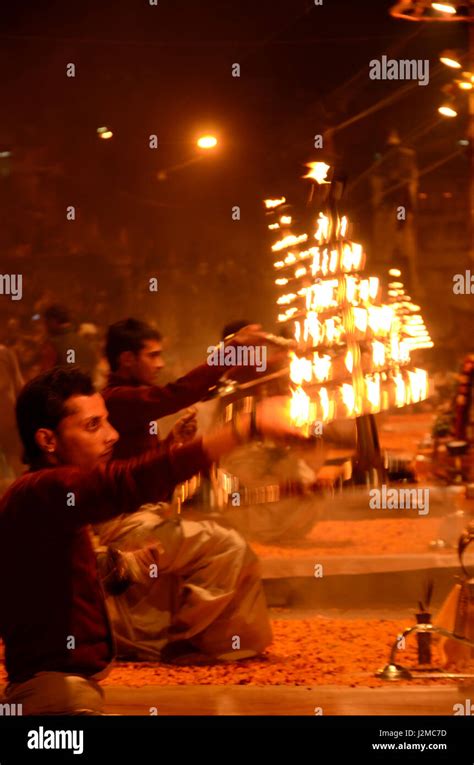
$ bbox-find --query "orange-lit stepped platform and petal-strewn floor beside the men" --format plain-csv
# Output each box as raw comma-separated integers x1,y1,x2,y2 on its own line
0,413,474,716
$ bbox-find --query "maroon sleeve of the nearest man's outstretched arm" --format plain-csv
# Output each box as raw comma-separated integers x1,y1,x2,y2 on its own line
12,439,210,534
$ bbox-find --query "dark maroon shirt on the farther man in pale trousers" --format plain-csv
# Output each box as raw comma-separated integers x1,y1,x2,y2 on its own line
102,364,228,459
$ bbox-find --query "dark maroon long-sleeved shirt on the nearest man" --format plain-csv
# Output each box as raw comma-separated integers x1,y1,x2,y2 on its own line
0,441,210,682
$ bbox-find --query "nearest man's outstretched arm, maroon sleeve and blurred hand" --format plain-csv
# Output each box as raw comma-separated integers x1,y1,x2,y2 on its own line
11,398,302,534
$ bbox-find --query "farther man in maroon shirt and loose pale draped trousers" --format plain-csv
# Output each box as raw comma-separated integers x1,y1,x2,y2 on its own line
94,319,284,663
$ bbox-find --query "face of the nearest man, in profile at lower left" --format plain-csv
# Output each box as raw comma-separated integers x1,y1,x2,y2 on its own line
50,393,118,469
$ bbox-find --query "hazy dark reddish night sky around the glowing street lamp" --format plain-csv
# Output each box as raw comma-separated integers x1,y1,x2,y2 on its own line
0,0,468,370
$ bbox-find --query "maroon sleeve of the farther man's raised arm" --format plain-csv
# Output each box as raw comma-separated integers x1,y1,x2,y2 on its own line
103,364,225,434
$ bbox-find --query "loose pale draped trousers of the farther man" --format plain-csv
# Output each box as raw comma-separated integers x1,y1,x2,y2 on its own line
95,506,272,660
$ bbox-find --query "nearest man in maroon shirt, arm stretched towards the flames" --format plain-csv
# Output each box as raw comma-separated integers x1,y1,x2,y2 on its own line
0,369,291,714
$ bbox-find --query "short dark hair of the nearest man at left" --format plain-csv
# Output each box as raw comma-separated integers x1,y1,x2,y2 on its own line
16,367,95,466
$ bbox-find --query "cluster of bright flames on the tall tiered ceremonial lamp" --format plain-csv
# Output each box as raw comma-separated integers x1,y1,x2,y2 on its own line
265,163,433,427
